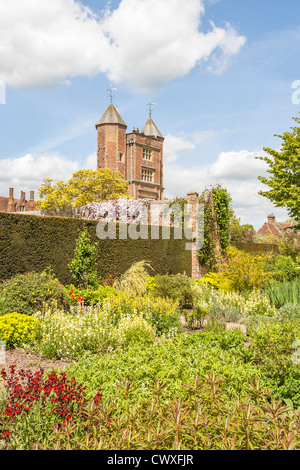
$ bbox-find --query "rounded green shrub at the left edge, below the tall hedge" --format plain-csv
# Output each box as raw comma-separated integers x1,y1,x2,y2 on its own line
0,272,71,315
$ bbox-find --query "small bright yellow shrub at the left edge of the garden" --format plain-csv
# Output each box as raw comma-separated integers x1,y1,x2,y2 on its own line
0,312,36,348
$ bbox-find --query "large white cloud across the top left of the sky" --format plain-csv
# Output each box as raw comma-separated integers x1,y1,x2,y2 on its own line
0,0,245,91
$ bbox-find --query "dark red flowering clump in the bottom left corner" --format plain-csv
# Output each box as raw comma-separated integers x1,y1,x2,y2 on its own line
0,365,101,450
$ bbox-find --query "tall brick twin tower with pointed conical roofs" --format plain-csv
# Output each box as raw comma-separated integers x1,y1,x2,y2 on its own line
96,103,164,200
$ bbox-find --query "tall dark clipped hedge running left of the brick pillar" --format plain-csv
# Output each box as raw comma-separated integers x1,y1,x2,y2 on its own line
0,213,191,284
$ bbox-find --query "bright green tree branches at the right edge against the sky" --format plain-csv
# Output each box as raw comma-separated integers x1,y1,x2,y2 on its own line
256,117,300,228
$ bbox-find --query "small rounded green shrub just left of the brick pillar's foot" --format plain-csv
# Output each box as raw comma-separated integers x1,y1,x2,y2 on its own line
151,274,194,309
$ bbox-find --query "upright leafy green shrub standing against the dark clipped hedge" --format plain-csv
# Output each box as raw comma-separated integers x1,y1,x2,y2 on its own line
69,228,97,289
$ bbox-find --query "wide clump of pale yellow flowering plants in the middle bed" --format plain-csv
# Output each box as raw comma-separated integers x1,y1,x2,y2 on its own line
34,291,180,359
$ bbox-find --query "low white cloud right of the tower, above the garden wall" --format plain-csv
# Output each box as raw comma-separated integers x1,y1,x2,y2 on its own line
164,144,288,229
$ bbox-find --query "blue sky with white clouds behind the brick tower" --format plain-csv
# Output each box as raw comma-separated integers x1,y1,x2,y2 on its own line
0,0,300,229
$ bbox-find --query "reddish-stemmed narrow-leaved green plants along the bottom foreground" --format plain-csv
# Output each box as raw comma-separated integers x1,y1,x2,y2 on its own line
32,372,300,450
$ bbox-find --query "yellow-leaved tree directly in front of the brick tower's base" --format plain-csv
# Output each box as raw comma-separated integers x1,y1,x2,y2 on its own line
37,168,129,217
